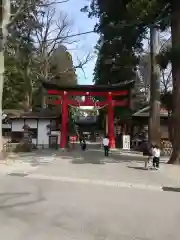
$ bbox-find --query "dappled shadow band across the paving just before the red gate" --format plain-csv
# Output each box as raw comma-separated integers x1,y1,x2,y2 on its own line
21,144,144,167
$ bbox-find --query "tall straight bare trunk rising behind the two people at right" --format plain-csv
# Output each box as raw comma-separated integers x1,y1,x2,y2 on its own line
148,26,161,144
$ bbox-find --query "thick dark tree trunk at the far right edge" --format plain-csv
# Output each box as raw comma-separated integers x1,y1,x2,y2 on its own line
169,0,180,164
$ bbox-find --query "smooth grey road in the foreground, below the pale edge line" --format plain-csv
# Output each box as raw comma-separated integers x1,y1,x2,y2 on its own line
0,176,180,240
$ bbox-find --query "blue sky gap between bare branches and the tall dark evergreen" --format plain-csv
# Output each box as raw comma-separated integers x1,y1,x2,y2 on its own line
59,0,98,84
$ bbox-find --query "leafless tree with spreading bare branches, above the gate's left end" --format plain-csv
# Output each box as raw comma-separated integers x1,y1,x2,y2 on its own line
36,4,77,80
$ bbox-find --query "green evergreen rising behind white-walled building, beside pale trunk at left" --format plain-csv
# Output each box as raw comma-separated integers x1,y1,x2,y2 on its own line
3,0,42,111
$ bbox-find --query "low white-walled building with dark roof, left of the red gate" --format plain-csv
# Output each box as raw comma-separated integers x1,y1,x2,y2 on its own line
2,109,60,148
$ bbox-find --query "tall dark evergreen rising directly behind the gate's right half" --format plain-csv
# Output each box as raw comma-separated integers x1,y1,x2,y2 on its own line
84,0,146,84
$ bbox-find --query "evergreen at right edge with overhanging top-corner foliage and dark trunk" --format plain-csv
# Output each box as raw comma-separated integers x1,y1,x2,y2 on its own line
126,0,180,163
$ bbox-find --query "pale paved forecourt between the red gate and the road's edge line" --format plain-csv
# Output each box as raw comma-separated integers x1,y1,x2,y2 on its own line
3,146,180,188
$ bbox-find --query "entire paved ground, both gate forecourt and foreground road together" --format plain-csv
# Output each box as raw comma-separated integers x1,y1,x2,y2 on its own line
0,148,180,240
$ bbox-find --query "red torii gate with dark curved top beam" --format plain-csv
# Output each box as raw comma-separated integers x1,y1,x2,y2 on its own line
43,81,134,148
